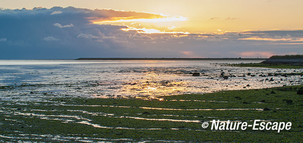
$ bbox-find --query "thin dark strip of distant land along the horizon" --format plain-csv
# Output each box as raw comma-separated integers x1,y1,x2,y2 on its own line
76,58,267,60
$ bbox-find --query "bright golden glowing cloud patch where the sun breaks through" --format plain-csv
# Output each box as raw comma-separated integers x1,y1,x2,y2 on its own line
88,10,189,34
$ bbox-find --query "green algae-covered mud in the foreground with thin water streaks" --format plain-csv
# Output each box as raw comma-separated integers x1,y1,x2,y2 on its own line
0,86,303,142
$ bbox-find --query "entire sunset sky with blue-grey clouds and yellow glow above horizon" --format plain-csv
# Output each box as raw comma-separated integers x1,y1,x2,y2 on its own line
0,0,303,59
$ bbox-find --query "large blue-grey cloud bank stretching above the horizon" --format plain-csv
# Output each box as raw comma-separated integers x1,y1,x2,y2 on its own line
0,7,303,59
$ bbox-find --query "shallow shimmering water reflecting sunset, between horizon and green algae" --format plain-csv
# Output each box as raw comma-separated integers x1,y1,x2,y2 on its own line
0,60,303,101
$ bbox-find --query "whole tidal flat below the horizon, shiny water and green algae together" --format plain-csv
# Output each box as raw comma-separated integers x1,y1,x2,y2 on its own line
0,61,303,142
